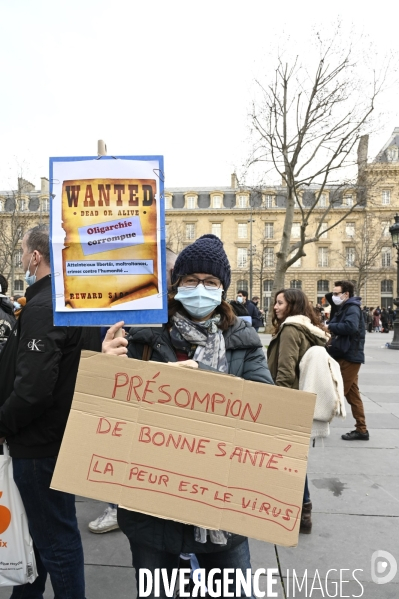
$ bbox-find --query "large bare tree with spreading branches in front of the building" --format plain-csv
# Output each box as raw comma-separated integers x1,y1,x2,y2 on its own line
248,34,381,328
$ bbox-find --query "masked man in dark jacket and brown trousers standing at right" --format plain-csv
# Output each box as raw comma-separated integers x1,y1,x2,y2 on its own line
326,281,369,441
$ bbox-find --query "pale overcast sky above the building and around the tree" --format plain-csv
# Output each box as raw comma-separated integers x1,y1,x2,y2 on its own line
0,0,399,189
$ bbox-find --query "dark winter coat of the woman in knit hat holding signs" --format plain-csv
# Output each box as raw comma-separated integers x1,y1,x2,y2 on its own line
118,320,273,555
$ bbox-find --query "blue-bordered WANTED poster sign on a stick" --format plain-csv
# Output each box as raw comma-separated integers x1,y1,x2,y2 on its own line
50,157,167,325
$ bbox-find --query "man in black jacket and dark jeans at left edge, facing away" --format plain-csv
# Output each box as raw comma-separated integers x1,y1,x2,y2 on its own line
0,225,85,599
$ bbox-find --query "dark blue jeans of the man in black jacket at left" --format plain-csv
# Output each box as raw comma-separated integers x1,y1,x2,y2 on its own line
10,457,85,599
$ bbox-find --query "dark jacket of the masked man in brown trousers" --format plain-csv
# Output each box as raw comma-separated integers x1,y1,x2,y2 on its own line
328,297,366,364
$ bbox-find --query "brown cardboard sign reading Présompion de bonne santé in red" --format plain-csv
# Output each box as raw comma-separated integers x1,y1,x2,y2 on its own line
52,352,315,546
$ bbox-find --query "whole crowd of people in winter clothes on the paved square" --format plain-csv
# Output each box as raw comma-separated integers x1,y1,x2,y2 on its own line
0,225,384,599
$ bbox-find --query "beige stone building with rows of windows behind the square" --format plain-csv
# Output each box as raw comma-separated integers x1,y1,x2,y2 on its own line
0,128,399,308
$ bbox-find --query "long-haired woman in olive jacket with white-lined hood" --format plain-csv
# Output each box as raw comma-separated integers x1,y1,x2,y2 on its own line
267,289,329,534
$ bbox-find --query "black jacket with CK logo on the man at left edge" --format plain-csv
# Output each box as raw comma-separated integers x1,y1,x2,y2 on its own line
0,276,82,458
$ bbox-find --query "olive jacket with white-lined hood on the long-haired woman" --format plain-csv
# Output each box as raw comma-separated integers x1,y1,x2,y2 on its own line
267,315,329,389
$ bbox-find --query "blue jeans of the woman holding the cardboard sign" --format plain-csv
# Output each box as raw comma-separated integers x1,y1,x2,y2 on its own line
130,539,253,599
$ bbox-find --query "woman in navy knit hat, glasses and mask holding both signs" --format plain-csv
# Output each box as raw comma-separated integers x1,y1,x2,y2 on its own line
103,235,273,597
